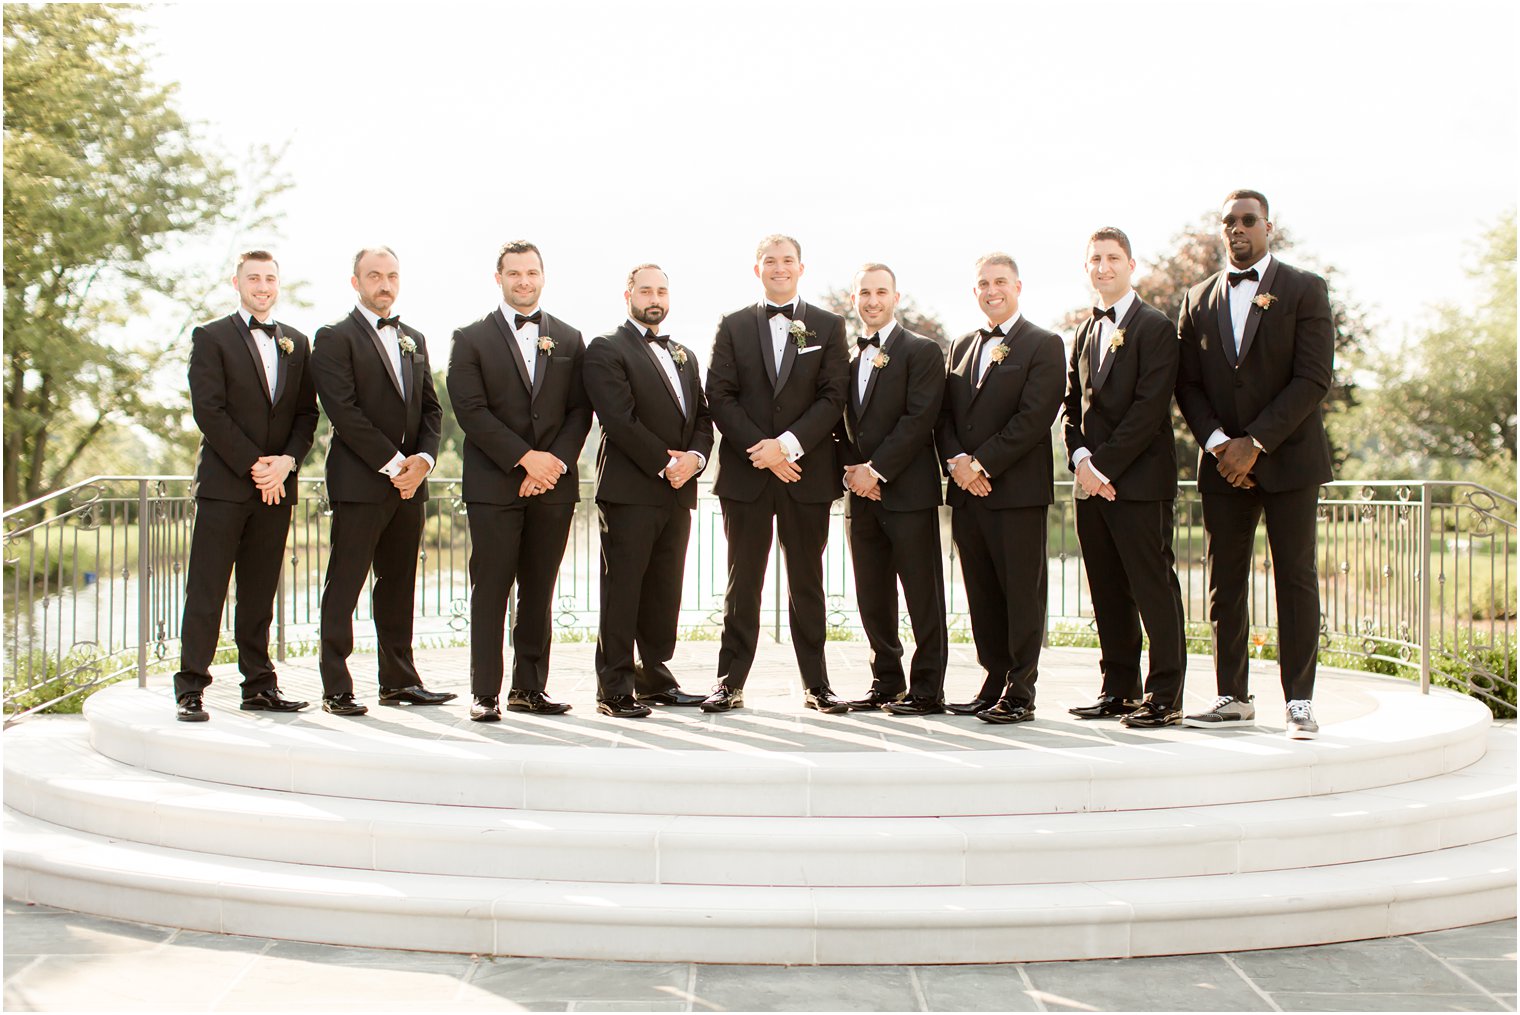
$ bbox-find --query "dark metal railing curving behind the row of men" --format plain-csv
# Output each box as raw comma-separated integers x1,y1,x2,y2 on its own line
3,476,1515,720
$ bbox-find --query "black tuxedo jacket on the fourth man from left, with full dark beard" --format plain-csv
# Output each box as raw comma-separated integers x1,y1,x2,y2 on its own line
585,321,713,509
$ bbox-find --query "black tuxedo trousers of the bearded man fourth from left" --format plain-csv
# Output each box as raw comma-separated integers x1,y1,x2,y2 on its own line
596,500,692,702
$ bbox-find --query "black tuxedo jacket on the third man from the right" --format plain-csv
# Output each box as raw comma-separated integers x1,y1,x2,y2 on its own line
938,316,1066,508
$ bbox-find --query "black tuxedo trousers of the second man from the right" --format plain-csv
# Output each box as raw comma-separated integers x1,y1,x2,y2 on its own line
1076,497,1187,710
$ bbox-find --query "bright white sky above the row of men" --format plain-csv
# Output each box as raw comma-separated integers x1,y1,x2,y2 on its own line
146,0,1517,366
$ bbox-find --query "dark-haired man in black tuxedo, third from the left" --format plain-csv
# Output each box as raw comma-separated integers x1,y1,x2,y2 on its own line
448,240,591,722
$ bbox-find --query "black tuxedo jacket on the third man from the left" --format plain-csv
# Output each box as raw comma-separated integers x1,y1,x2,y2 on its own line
448,307,591,504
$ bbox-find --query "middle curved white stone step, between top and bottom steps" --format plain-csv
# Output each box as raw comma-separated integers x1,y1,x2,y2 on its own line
5,723,1515,887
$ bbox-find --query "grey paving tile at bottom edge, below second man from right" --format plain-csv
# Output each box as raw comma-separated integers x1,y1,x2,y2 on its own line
1024,956,1271,1012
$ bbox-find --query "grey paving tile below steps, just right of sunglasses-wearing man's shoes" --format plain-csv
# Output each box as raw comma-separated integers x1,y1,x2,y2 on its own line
1230,938,1474,995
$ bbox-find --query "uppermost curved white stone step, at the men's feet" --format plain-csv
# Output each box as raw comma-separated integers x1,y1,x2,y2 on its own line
85,681,1491,817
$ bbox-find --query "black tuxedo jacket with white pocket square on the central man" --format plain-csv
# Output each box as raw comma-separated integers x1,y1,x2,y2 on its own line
707,299,850,503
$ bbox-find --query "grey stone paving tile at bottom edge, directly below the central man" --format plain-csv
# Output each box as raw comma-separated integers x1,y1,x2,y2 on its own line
692,966,920,1012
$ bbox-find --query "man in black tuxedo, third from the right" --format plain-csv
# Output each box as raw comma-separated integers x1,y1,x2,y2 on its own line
938,254,1066,723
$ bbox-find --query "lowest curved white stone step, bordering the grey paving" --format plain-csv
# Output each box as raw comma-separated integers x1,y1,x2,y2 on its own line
5,808,1515,963
